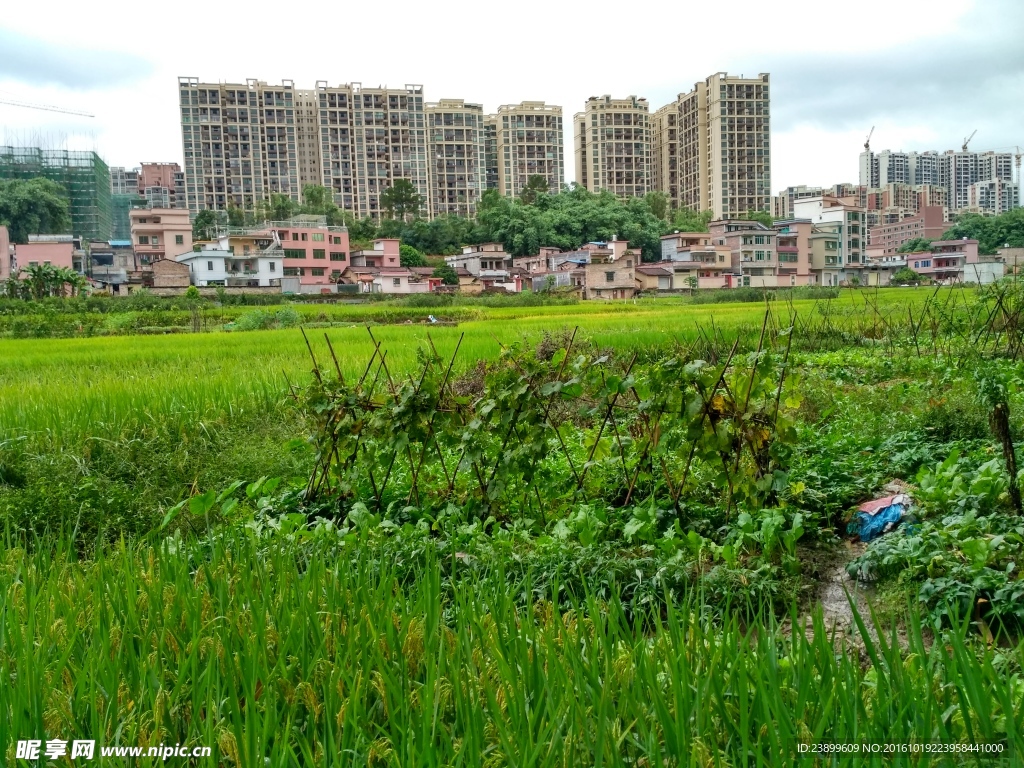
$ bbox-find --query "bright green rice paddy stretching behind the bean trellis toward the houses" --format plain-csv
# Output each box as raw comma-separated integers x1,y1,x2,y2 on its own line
0,289,931,445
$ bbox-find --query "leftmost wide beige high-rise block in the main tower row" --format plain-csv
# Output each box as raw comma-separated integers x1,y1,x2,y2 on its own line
178,77,300,215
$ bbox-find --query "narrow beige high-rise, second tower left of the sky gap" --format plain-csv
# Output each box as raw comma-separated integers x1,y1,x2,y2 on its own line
424,98,486,216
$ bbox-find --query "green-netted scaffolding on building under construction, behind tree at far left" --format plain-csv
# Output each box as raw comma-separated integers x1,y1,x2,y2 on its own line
0,146,114,241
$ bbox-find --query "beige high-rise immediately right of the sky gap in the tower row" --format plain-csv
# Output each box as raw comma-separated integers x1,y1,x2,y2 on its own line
573,96,652,198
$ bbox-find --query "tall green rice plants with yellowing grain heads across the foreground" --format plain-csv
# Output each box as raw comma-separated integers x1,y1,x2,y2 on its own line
0,531,1024,767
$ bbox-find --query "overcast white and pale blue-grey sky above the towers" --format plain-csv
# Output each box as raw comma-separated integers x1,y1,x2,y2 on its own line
0,0,1024,191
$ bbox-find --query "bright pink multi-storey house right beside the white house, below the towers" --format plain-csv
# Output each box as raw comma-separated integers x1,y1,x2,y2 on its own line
270,216,354,286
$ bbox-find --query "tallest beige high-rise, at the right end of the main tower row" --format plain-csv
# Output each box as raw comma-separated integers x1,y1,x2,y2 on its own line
655,72,772,219
